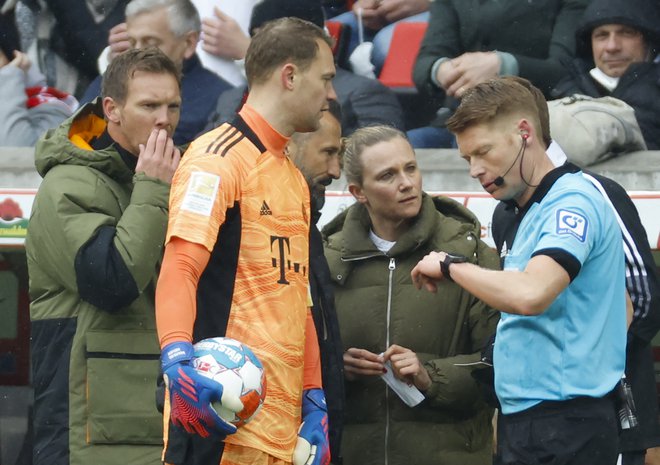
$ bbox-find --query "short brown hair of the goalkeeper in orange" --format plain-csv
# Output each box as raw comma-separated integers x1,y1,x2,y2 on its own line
245,18,332,87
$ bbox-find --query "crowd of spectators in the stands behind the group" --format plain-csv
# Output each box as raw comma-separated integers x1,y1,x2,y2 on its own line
0,0,660,158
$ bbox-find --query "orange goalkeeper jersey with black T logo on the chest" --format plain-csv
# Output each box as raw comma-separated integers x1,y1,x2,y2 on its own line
159,106,310,460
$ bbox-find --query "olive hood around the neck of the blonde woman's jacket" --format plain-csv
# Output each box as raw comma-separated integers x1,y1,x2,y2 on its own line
322,193,481,277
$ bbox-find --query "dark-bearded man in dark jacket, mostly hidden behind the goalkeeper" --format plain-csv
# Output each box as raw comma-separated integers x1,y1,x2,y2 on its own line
289,100,345,464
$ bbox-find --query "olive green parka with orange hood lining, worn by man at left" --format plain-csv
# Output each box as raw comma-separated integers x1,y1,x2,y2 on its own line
25,104,170,465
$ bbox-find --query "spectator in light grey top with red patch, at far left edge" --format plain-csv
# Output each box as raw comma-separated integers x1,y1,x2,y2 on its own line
0,10,78,147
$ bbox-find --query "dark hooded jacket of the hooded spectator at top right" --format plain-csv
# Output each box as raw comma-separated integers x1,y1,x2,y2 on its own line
552,0,660,150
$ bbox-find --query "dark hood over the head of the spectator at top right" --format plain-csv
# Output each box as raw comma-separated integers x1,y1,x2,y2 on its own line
575,0,660,61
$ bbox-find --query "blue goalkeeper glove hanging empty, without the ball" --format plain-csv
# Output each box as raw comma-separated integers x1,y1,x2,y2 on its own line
293,389,330,465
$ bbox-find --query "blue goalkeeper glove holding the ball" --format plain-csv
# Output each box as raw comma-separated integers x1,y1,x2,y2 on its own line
161,342,243,438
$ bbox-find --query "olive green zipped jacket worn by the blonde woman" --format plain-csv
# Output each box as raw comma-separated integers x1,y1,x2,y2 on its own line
323,194,499,465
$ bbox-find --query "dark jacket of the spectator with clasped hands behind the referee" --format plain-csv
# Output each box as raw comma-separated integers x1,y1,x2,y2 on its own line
413,0,588,101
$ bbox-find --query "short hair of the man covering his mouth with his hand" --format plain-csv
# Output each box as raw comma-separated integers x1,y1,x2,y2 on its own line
101,47,181,103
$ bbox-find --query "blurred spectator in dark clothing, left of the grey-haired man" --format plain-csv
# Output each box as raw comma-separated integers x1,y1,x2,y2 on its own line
7,0,128,97
